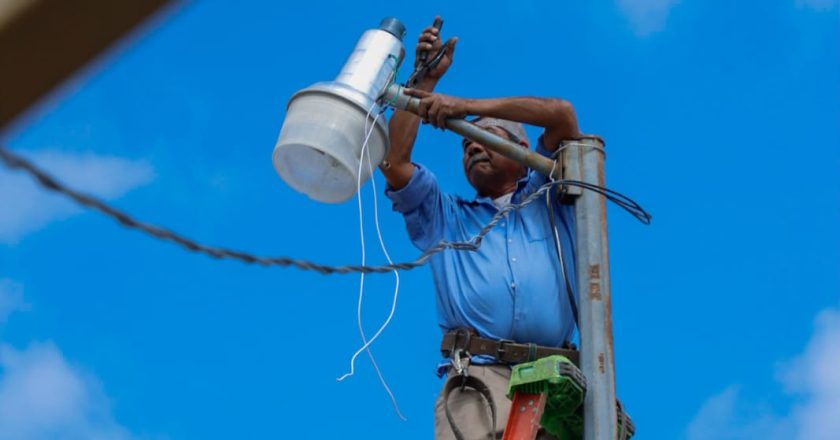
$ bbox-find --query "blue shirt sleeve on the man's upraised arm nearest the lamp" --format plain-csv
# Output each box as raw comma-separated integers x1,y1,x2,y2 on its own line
385,164,448,251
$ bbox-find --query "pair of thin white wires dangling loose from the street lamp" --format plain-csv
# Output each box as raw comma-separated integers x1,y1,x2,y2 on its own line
337,106,407,421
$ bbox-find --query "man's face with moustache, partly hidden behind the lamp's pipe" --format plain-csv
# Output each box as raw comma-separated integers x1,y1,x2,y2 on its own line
461,126,528,197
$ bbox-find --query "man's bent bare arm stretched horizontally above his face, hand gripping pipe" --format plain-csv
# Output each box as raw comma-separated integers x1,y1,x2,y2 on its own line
406,89,580,151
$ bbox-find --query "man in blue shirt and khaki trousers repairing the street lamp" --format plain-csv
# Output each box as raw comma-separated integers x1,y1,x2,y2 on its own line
381,19,579,439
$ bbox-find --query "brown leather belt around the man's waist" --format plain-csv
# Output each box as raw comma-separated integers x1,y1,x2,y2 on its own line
440,329,580,366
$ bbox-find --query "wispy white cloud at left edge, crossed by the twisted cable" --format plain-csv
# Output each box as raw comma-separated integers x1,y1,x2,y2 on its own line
0,151,154,244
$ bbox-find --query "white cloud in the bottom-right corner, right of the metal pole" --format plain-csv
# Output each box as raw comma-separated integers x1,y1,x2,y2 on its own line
686,309,840,440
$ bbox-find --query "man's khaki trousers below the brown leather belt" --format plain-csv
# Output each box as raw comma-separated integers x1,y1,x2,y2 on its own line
435,365,554,440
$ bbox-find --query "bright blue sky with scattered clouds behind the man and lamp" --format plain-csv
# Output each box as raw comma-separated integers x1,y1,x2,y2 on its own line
0,0,840,440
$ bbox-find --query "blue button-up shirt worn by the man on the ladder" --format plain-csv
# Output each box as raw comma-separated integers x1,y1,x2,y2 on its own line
385,139,576,347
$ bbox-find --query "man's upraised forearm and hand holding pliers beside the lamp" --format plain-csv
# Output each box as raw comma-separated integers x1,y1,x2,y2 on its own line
380,20,458,190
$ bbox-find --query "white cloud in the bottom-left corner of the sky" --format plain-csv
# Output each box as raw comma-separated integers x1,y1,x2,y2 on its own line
0,343,132,440
